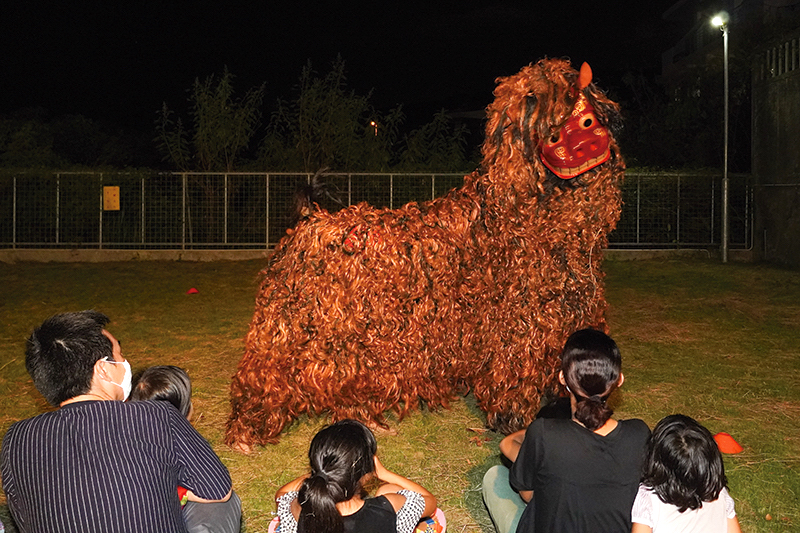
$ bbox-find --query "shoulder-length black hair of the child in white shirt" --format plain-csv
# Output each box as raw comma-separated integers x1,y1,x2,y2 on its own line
642,415,728,513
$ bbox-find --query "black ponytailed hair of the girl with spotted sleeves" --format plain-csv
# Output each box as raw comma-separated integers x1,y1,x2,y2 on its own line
297,420,378,533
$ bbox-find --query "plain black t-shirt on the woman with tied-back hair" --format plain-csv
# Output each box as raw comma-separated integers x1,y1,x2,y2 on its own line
509,418,650,533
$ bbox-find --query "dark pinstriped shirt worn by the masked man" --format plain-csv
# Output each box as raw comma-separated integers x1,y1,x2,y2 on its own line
2,401,231,533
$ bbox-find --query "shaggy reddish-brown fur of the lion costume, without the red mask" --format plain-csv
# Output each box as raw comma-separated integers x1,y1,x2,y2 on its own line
226,59,624,449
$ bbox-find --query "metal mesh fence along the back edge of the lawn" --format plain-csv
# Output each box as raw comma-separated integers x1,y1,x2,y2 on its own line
0,172,752,249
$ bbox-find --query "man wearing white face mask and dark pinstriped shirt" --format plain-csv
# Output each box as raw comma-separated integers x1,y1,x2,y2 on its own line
2,311,241,533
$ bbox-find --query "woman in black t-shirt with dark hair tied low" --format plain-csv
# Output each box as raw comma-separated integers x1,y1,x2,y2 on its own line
483,329,650,533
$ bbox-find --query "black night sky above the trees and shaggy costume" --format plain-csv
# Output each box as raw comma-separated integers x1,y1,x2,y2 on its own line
0,0,674,131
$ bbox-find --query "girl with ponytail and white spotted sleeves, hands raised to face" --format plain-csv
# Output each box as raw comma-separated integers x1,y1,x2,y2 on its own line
275,420,436,533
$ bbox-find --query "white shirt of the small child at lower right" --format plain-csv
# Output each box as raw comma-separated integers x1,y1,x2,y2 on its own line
631,485,736,533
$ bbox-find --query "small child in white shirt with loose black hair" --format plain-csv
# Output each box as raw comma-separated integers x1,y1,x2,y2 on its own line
632,415,741,533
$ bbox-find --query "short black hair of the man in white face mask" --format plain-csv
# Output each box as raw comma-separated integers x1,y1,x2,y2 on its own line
25,310,114,407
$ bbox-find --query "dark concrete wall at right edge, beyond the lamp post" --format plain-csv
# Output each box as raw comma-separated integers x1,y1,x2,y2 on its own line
752,32,800,266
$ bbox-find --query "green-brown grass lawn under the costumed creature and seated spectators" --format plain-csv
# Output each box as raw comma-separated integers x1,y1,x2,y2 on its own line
0,261,800,533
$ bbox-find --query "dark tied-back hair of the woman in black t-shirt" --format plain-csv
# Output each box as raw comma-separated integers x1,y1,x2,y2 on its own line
561,329,622,431
